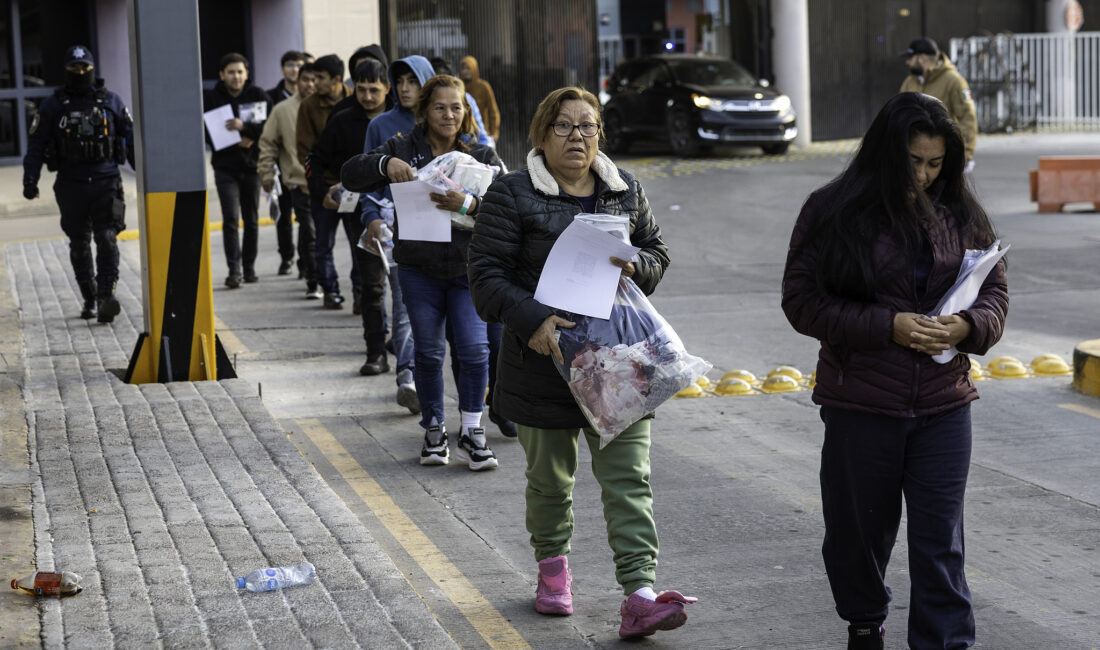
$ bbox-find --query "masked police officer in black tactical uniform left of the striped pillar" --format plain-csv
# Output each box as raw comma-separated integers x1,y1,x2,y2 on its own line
23,45,134,322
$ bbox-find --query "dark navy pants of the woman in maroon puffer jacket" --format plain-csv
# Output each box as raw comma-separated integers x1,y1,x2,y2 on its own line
821,405,975,649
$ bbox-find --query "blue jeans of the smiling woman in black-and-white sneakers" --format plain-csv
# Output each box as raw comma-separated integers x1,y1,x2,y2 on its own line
398,266,488,429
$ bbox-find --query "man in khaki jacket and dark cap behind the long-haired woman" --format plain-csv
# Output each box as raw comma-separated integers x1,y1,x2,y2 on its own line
899,37,978,172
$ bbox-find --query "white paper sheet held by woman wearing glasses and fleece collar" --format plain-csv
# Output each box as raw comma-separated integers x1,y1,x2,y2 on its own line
534,221,640,319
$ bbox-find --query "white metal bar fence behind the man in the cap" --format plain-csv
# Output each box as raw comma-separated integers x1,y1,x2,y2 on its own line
949,32,1100,133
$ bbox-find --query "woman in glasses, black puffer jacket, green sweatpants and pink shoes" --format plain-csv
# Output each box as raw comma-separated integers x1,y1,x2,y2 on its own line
470,88,693,637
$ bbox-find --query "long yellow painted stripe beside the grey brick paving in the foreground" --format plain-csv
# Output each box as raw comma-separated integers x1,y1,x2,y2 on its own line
296,419,530,648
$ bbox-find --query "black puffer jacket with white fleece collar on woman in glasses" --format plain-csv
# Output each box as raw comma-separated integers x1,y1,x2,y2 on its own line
469,152,669,429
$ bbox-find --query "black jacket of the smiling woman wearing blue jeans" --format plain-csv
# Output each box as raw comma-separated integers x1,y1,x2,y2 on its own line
340,126,503,278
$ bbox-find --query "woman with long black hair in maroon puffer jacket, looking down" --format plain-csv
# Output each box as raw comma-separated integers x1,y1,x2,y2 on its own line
783,92,1009,648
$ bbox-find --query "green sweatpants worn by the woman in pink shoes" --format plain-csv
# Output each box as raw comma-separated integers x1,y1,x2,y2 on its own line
516,419,657,595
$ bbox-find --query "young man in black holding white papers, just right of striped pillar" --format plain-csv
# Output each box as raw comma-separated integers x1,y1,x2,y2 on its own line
202,52,272,289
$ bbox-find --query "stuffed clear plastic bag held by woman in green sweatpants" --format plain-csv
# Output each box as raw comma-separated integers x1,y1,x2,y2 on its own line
554,277,712,449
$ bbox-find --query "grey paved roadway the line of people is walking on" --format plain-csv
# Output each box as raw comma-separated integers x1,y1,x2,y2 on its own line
4,133,1100,649
